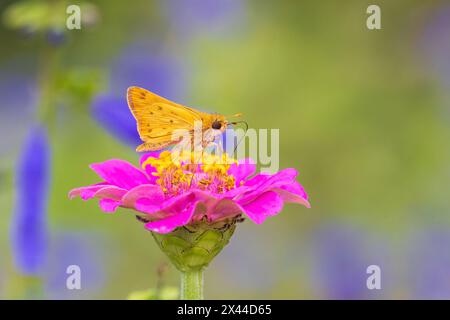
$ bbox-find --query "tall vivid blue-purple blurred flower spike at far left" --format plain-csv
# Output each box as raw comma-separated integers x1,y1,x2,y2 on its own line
12,126,50,275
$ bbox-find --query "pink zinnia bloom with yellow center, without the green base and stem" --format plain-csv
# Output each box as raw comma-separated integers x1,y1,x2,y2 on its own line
69,151,310,234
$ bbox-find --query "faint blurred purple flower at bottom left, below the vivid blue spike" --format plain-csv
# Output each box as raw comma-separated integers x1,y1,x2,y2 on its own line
44,232,106,299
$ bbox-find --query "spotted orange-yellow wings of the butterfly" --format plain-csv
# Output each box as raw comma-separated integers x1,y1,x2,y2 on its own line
127,87,210,151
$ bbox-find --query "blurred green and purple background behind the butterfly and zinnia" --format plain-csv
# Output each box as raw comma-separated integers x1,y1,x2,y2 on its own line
0,0,450,299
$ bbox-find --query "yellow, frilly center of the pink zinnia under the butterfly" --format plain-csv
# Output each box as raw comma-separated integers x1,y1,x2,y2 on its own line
142,151,237,195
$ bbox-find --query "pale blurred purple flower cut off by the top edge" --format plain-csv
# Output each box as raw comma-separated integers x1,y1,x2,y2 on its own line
161,0,246,39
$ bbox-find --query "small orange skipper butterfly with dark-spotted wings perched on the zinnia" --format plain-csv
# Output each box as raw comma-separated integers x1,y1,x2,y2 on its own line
127,87,240,152
